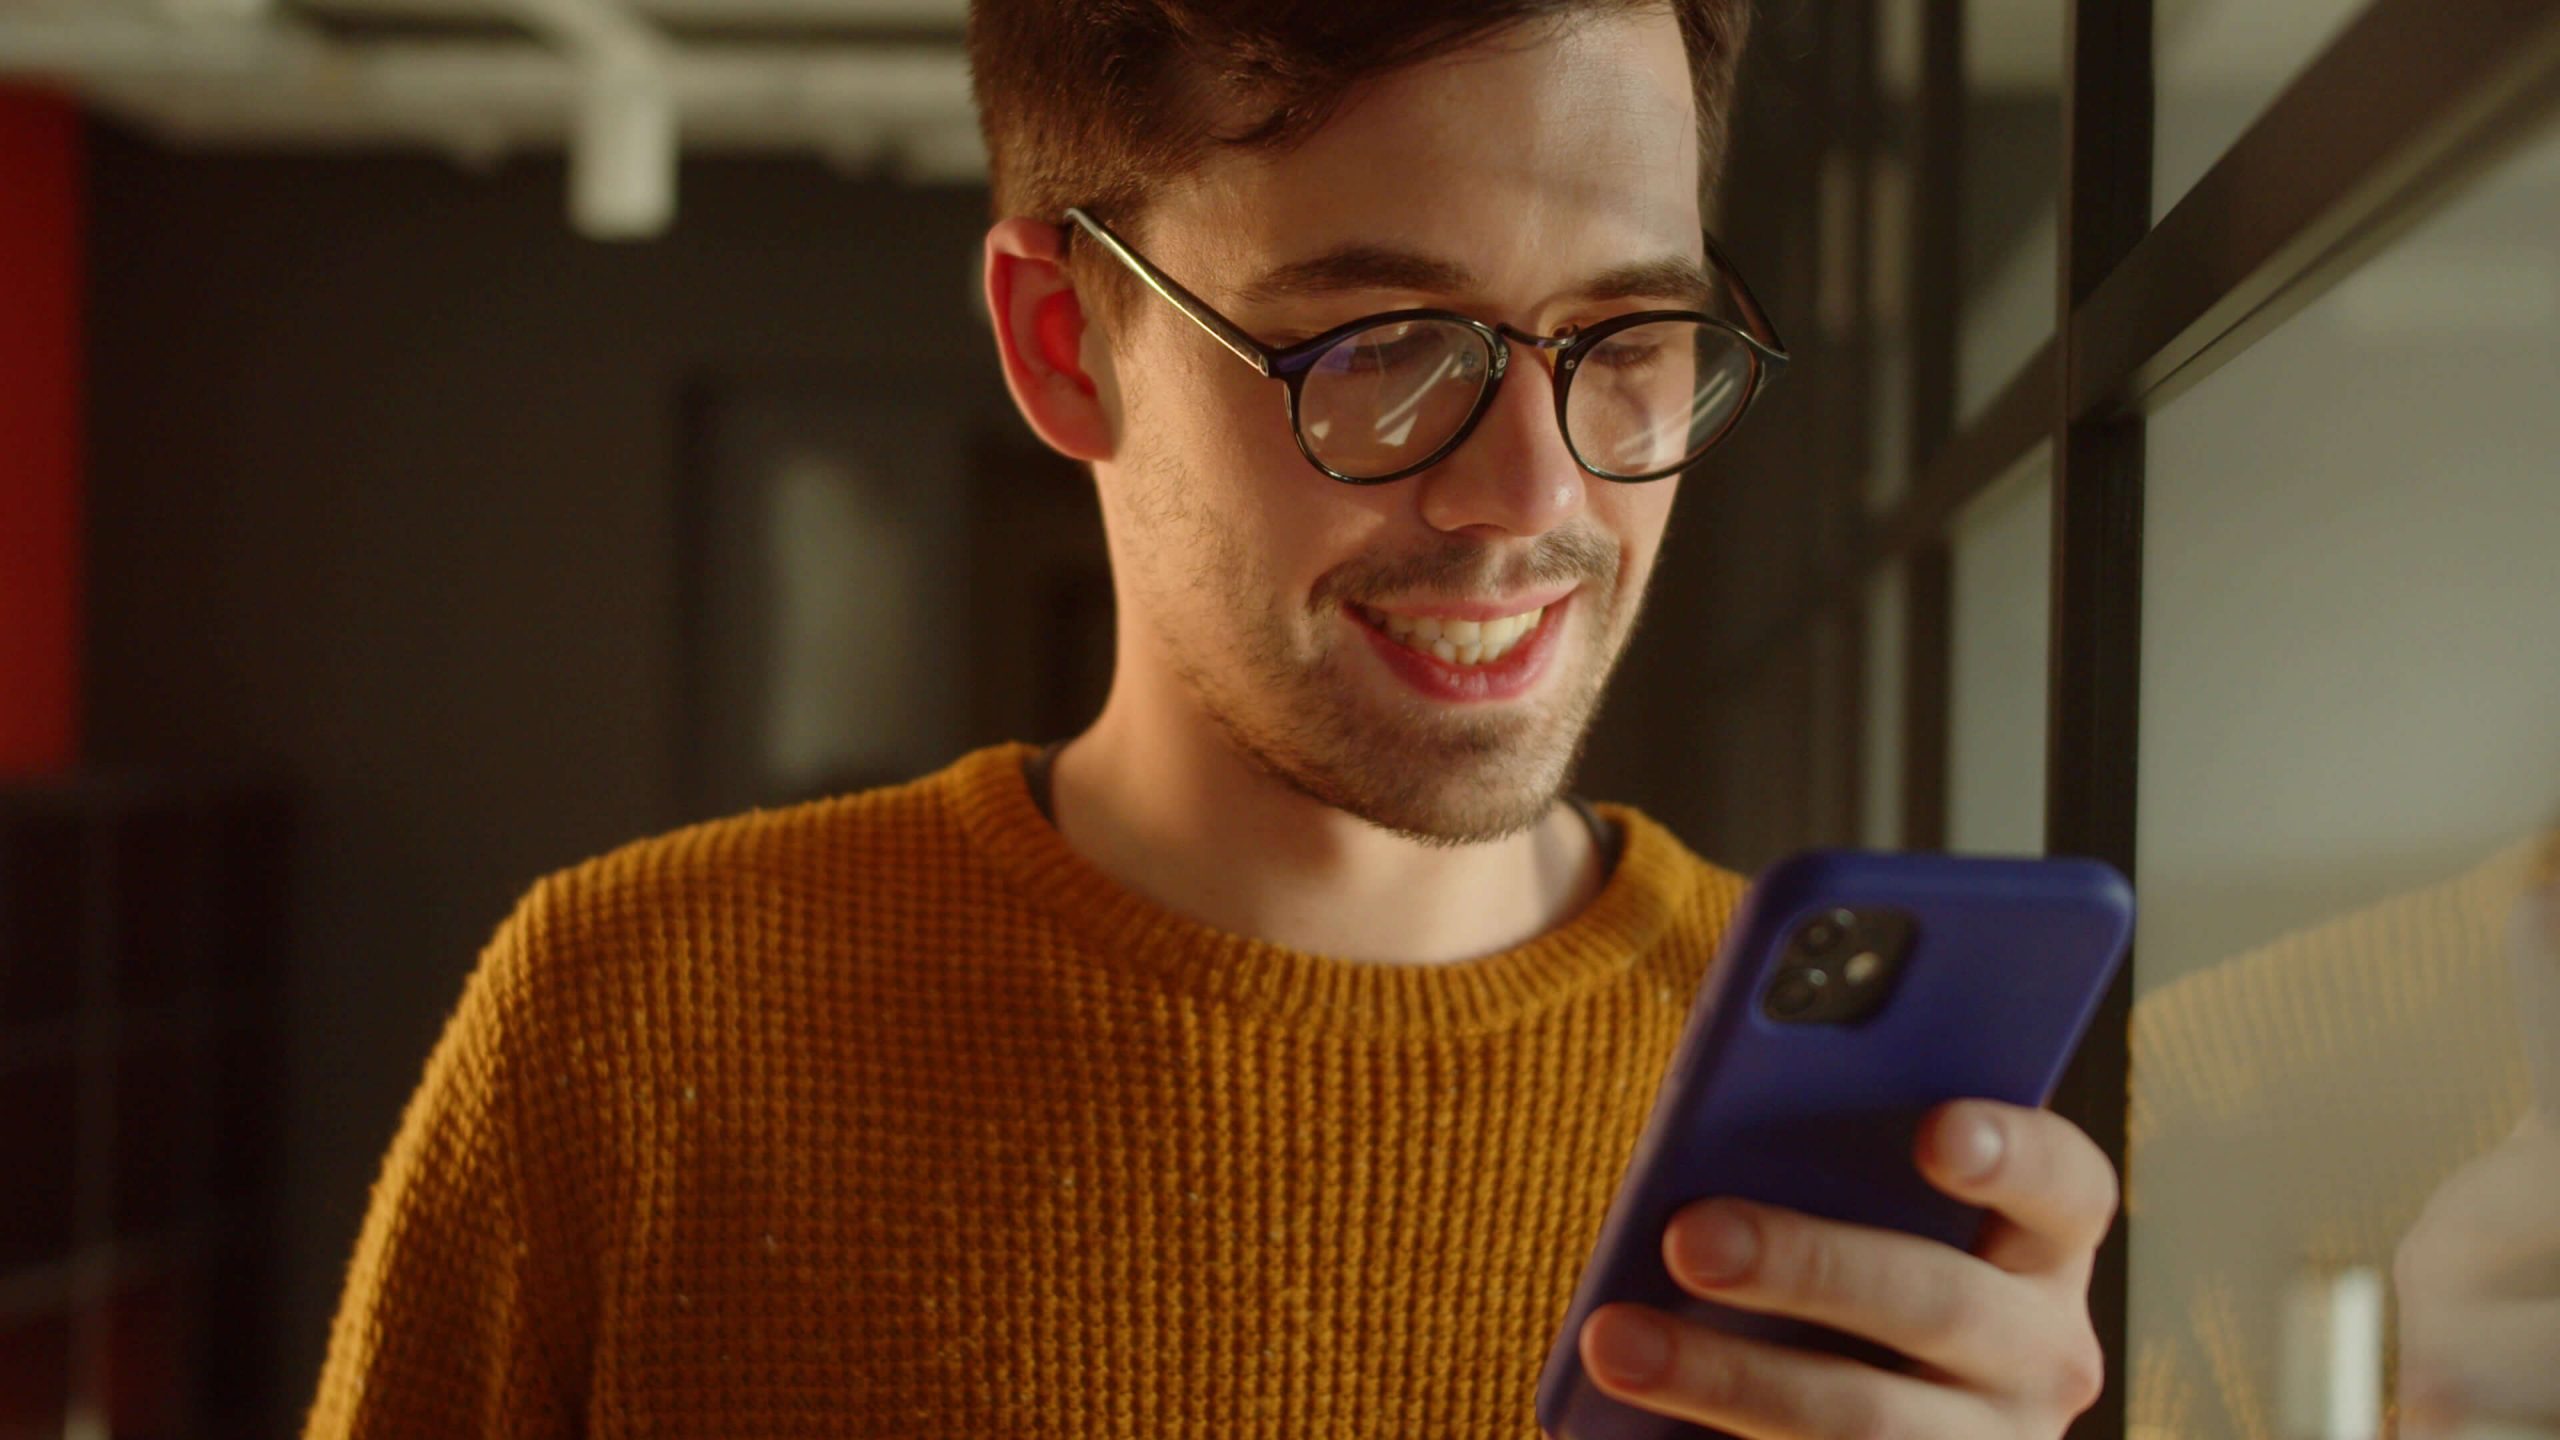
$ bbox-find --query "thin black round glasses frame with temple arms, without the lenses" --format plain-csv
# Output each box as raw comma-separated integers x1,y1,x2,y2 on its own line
1068,208,1787,484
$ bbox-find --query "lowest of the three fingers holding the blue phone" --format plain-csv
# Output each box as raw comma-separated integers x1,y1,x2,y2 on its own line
1580,1304,2002,1440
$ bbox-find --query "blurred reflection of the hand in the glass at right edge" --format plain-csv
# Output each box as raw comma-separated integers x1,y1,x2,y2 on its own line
2391,1112,2560,1440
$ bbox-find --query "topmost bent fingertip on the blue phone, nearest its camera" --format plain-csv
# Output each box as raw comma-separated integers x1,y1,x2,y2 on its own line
1917,1099,2117,1273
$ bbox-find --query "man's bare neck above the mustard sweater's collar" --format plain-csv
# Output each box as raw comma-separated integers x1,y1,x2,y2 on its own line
1050,710,1608,963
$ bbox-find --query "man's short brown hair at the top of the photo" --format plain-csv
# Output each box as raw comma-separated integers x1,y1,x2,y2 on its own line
968,0,1751,310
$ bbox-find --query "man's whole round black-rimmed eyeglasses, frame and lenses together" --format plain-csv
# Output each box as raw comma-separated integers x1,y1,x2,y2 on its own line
1068,208,1787,484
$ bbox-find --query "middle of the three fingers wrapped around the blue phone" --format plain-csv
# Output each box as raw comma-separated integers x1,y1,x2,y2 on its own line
1661,1199,2104,1391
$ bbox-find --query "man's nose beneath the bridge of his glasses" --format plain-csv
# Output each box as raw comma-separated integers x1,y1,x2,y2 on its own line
1416,341,1590,538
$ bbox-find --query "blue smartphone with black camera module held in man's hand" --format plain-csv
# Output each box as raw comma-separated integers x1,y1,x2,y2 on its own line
1539,851,2132,1440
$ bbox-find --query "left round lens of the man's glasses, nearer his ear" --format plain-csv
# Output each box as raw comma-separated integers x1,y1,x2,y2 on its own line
1298,320,1492,479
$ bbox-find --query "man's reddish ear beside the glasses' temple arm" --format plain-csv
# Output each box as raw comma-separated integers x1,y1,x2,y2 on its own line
986,218,1114,461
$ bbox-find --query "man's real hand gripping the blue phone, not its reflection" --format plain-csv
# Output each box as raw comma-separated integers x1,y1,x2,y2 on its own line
1582,1099,2117,1440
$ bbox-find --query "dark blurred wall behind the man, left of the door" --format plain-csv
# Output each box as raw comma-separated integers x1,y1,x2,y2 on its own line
87,131,1029,1414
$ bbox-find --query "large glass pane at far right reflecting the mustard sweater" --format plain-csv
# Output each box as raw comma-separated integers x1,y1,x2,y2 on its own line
2127,112,2560,1440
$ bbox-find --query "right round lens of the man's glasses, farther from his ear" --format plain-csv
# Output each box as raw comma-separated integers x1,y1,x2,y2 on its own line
1564,320,1759,479
